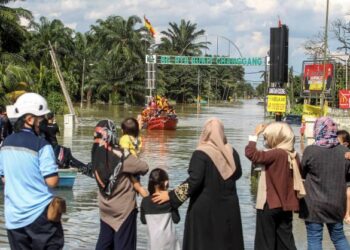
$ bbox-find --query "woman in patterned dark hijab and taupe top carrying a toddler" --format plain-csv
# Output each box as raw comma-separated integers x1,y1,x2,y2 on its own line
91,120,148,250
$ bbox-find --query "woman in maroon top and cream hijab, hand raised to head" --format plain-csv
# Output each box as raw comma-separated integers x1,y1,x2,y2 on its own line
245,122,305,250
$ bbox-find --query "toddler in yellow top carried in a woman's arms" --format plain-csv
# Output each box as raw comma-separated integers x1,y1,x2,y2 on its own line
119,117,148,197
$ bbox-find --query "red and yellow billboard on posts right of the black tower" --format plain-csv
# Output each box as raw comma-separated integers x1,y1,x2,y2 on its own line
303,63,334,93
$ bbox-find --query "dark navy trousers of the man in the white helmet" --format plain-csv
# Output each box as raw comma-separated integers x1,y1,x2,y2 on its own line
7,208,64,250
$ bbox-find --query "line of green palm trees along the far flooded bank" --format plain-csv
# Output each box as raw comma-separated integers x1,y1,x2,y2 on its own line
0,0,255,111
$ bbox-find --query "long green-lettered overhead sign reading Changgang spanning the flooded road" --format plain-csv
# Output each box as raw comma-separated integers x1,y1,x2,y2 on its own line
146,55,264,66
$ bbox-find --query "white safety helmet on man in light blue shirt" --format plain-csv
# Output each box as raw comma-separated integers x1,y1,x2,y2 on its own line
6,93,51,119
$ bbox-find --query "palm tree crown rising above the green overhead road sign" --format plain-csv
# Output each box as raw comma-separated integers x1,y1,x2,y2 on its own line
159,19,210,56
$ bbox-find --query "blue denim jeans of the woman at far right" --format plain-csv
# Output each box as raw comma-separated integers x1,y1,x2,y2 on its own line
305,222,350,250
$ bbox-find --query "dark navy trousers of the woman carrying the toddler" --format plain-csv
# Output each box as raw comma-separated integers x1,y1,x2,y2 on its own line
96,209,137,250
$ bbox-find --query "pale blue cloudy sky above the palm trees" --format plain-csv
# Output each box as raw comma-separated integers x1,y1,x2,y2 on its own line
10,0,350,85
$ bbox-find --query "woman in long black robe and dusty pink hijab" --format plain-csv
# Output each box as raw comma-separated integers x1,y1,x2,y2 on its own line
153,118,244,250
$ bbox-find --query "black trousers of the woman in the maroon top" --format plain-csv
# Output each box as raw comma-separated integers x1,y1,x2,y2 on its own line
254,204,296,250
